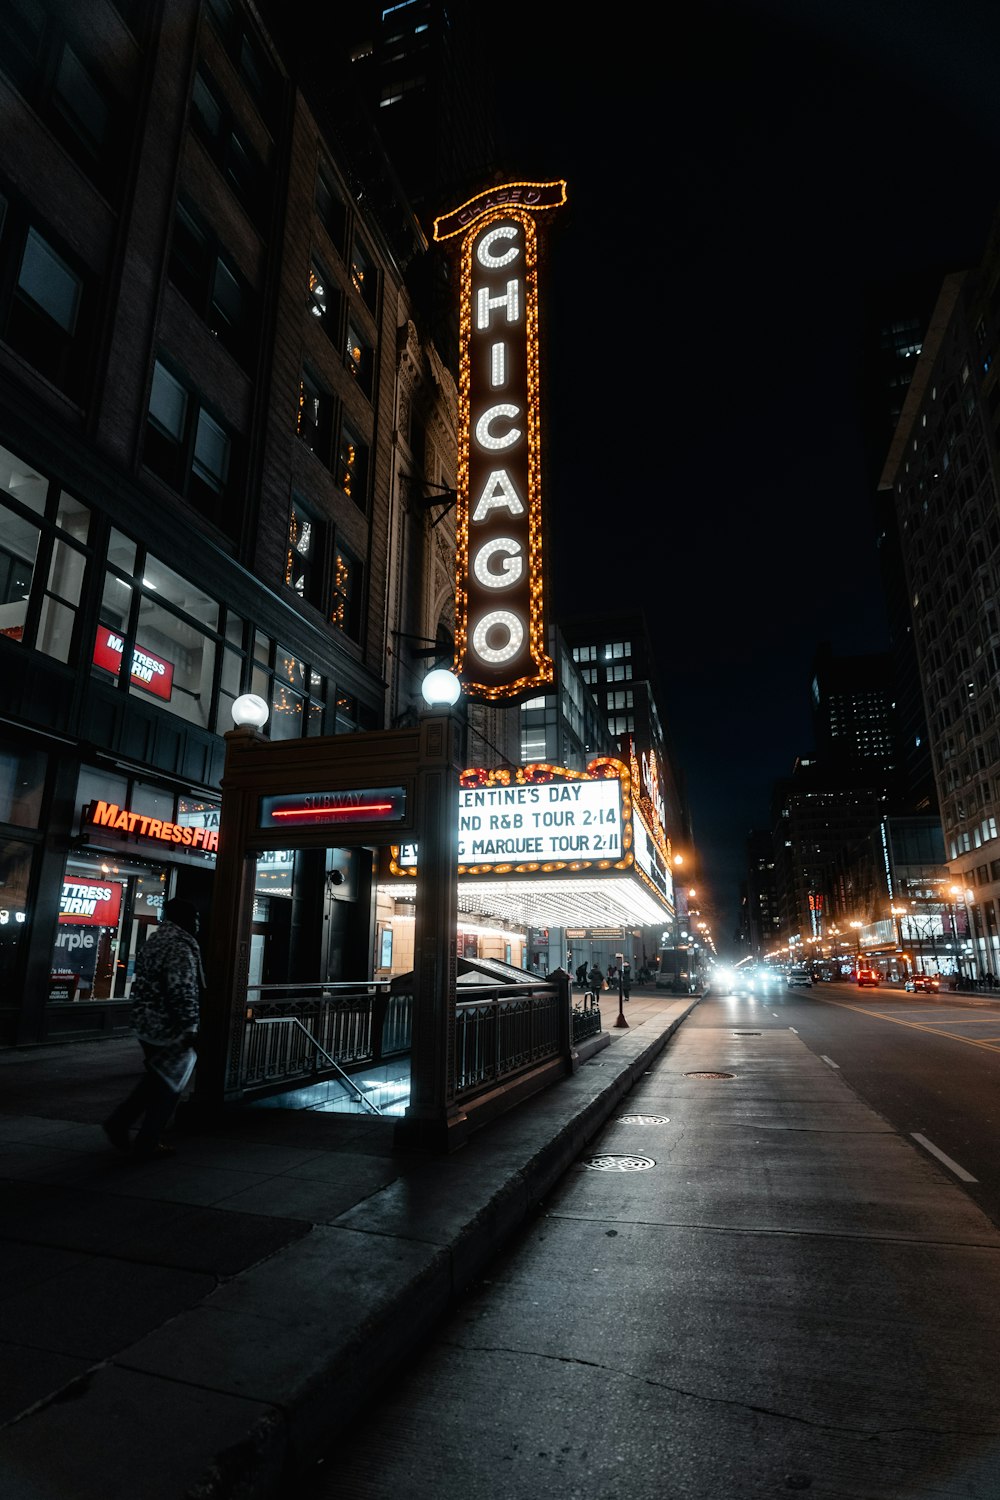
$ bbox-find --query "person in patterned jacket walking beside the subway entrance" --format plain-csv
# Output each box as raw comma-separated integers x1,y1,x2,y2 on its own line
103,899,205,1160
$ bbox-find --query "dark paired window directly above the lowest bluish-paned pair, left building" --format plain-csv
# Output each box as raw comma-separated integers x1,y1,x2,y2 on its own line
169,203,256,366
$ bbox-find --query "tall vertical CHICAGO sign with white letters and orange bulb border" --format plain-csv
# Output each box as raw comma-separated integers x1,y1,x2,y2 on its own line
435,182,565,702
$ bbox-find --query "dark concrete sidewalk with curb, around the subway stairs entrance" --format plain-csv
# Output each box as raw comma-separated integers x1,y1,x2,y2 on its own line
0,990,697,1500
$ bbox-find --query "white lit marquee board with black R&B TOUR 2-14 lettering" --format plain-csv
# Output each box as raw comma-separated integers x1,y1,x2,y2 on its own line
399,779,622,867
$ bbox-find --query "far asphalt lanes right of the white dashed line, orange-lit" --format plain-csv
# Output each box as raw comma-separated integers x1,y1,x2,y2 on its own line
722,984,1000,1227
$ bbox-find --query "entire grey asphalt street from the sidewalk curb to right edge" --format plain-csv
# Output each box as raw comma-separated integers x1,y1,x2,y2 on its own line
313,987,1000,1500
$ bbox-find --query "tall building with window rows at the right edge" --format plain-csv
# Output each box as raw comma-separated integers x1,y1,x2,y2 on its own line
882,214,1000,974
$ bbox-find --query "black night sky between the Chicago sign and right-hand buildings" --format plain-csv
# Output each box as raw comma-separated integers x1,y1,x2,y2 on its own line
498,0,1000,951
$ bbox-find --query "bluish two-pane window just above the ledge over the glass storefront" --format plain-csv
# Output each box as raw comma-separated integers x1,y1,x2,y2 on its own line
142,360,232,521
